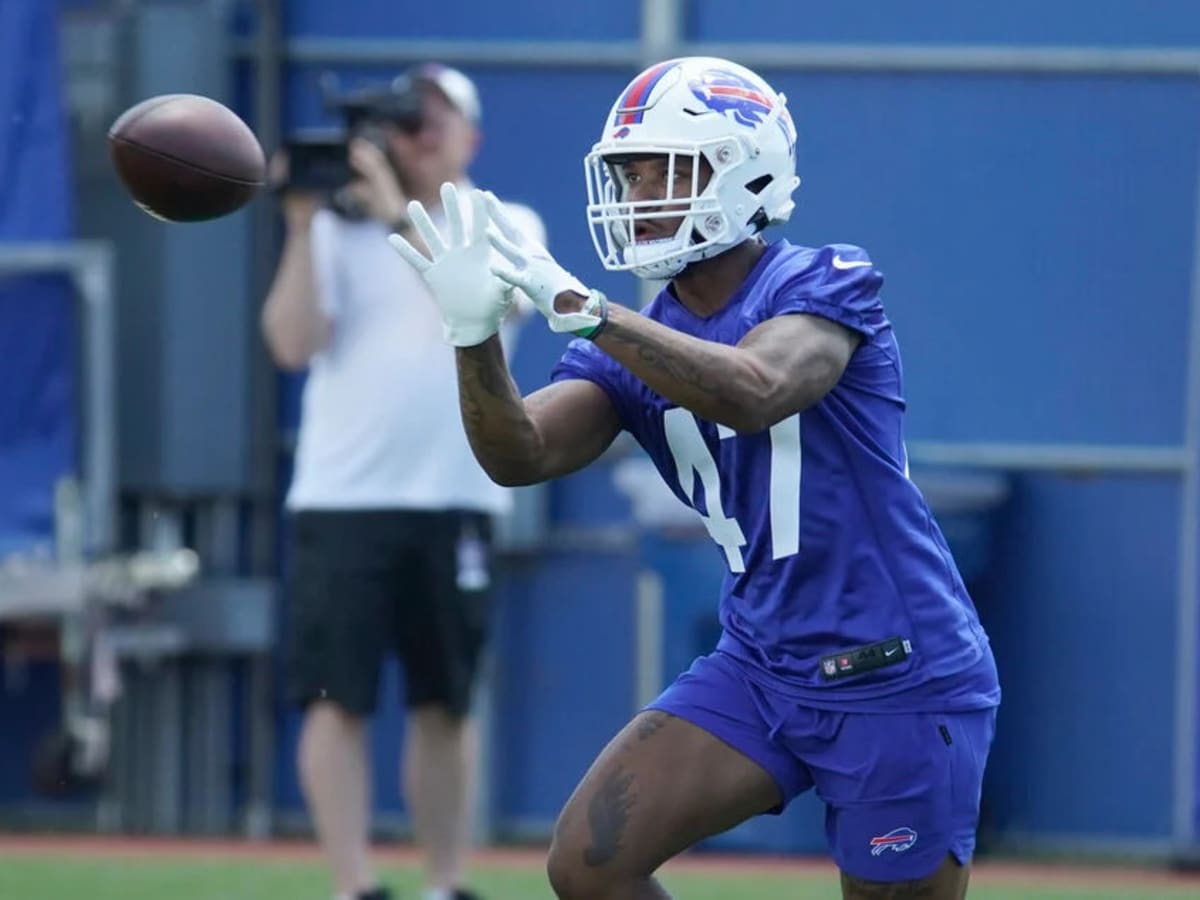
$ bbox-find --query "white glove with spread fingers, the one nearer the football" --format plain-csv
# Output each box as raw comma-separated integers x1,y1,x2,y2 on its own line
388,181,512,347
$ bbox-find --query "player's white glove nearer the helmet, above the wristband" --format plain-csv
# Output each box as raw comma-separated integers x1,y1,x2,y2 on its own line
476,191,602,334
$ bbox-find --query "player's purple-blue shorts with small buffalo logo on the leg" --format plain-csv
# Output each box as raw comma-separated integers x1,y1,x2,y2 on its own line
648,653,996,881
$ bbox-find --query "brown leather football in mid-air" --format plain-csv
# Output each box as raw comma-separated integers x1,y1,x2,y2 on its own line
108,94,266,222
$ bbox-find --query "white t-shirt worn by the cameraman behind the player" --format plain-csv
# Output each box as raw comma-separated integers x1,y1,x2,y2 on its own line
287,191,545,514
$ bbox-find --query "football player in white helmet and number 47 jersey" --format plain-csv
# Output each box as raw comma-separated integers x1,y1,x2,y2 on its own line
391,58,1000,900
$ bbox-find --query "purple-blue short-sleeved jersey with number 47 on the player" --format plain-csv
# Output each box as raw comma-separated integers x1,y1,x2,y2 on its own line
552,241,1000,712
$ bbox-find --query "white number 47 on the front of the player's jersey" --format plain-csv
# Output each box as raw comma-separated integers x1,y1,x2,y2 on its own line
662,407,800,572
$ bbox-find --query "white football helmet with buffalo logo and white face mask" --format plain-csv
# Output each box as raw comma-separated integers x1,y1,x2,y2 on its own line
583,56,800,278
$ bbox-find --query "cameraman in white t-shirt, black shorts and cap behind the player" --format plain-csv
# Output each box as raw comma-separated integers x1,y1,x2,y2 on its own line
262,65,544,900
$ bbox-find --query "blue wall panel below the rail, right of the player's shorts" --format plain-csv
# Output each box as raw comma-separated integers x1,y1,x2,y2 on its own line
977,475,1180,839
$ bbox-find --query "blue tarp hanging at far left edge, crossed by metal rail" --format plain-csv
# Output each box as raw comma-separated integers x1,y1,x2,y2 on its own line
0,0,78,557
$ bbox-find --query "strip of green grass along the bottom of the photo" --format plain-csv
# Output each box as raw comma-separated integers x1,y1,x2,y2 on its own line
0,850,1200,900
